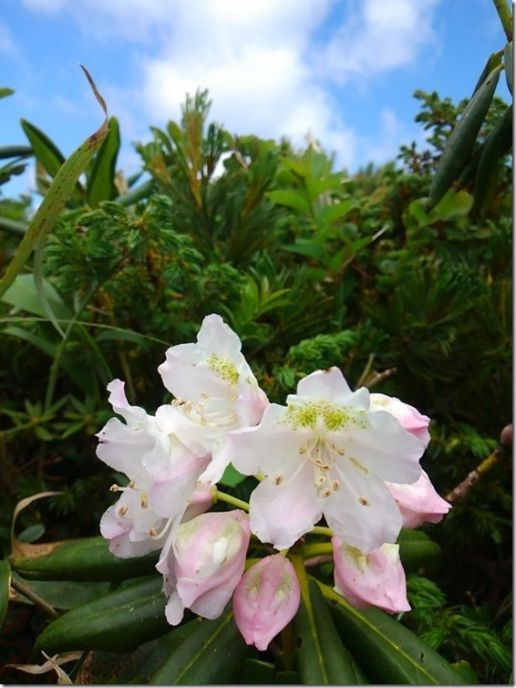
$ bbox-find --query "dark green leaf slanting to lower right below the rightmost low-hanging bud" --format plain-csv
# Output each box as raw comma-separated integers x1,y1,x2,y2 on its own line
318,582,467,685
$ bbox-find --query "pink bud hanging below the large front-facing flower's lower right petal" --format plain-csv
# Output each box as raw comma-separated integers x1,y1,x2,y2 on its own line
332,537,410,614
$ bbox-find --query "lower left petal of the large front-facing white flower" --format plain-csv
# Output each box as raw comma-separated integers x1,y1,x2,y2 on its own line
249,462,322,549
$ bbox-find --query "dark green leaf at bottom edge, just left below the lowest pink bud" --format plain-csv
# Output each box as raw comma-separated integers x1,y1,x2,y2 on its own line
150,611,249,685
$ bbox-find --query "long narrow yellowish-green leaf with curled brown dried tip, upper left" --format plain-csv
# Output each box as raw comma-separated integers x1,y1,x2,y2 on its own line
0,70,107,297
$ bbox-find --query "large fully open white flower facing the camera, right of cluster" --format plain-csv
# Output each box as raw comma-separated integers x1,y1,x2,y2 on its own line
225,368,426,553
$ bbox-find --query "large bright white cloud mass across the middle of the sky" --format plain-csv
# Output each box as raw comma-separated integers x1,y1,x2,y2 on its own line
19,0,439,169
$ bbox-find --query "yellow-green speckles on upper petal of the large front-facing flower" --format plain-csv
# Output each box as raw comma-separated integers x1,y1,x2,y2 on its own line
285,401,367,432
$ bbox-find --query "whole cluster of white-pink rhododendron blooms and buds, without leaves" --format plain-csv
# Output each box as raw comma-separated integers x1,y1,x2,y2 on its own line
97,315,449,650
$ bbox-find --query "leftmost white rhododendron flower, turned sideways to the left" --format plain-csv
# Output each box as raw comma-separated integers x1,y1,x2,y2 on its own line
97,380,210,557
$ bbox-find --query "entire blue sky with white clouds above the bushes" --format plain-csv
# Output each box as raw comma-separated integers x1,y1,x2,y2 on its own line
0,0,508,194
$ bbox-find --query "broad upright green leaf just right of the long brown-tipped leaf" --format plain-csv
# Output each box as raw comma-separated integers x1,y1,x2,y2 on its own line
86,117,120,208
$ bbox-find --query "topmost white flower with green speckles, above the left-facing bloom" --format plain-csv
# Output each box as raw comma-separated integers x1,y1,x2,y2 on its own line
157,315,268,482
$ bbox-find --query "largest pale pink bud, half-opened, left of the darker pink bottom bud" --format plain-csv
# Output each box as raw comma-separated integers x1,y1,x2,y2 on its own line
158,510,250,626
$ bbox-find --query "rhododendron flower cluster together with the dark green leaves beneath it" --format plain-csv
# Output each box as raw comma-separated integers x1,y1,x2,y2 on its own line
4,314,470,683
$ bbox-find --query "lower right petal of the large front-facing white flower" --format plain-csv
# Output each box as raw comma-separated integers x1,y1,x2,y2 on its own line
323,464,402,552
